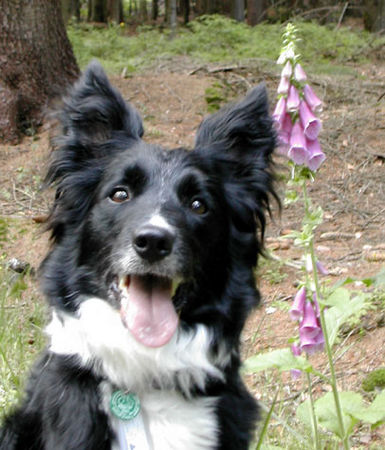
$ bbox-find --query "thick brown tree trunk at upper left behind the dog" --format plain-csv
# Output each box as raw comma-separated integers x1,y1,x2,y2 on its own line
0,0,79,142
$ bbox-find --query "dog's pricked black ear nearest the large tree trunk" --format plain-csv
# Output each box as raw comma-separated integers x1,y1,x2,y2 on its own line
60,61,143,145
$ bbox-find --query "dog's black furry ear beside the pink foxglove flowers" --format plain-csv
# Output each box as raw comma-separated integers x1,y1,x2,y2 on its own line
195,85,277,239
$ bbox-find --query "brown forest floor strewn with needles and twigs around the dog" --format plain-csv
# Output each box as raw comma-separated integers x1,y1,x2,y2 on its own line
0,60,385,447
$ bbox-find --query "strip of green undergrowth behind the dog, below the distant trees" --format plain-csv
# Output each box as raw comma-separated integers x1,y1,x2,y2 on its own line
68,15,385,74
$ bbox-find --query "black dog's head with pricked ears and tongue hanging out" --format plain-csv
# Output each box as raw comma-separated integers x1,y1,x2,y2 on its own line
42,63,275,347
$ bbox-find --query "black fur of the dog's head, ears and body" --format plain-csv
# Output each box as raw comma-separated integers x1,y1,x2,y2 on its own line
0,63,275,450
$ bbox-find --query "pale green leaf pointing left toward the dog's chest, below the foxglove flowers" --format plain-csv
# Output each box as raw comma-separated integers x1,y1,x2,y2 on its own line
243,348,313,373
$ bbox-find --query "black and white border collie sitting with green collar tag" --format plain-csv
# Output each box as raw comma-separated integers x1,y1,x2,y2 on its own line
0,62,275,450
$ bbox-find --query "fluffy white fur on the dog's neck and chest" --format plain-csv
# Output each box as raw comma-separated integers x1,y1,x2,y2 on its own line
47,298,229,450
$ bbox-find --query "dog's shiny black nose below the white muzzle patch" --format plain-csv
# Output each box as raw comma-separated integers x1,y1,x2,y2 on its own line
133,225,175,262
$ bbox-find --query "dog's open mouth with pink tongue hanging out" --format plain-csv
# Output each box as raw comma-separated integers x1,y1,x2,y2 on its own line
120,275,178,347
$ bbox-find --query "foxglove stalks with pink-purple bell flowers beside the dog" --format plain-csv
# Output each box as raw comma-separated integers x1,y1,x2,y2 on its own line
274,24,350,450
